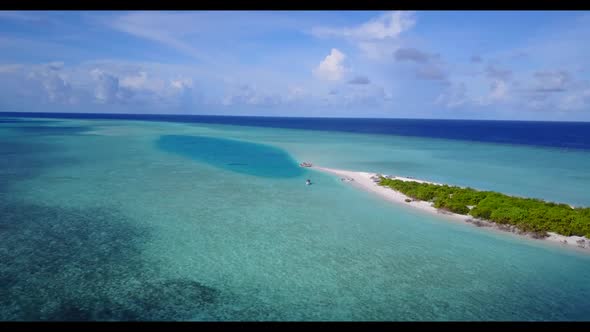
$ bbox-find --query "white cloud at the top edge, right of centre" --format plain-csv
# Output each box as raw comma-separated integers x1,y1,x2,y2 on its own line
312,11,416,40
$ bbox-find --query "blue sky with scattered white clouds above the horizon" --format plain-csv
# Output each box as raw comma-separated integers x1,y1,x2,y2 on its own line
0,11,590,121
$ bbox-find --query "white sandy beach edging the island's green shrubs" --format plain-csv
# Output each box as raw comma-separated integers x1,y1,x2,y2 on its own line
309,166,590,253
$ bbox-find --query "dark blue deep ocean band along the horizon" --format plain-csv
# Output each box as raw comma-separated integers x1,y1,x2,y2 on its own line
0,112,590,150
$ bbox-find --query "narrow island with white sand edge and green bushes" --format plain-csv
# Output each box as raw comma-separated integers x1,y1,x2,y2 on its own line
312,166,590,251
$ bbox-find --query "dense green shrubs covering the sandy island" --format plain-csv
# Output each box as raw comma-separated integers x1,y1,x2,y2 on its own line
379,177,590,237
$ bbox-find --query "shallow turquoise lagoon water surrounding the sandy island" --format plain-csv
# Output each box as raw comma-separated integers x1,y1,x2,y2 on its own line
0,120,590,320
